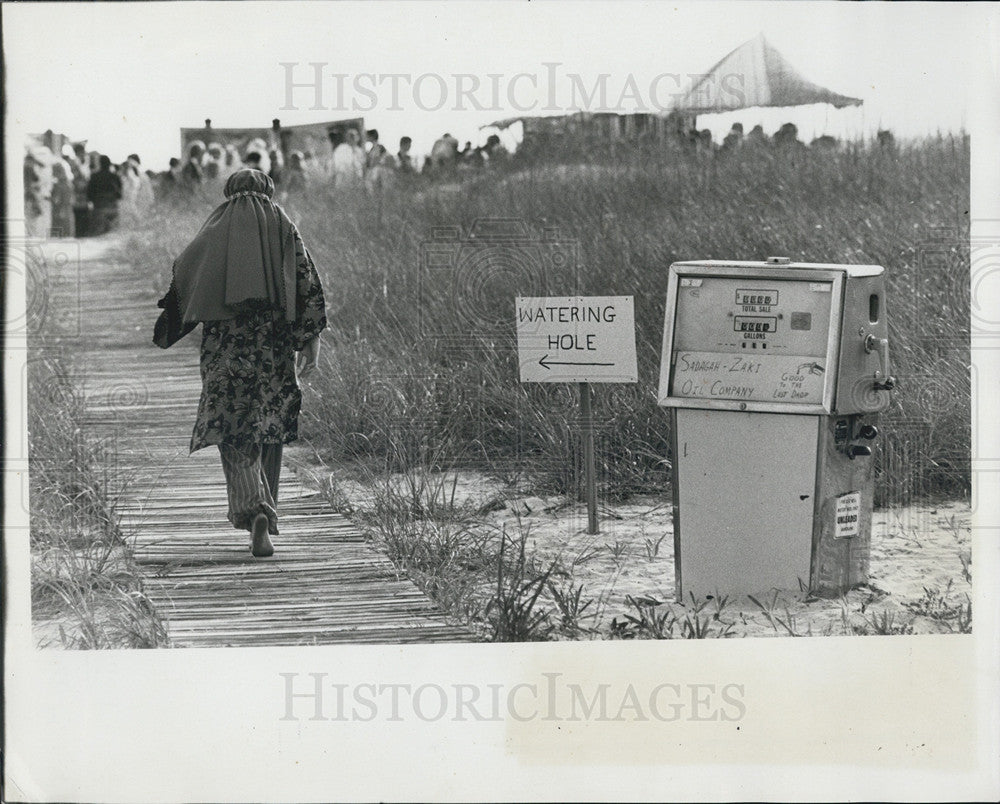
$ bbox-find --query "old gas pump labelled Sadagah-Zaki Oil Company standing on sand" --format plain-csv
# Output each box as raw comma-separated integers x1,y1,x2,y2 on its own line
658,257,895,600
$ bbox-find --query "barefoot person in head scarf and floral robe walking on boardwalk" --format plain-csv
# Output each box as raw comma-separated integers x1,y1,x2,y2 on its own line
153,169,327,557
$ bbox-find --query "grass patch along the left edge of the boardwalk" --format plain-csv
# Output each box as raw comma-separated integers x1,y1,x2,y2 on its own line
28,350,166,649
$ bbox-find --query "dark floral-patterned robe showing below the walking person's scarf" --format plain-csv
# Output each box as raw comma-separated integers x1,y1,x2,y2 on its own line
191,232,327,452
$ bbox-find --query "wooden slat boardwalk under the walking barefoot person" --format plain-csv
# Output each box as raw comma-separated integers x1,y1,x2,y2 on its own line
41,240,474,647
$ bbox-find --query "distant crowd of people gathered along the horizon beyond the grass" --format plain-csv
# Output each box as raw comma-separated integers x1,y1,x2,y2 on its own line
24,118,893,237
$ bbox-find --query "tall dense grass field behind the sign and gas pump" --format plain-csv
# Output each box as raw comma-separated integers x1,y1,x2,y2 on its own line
289,138,970,504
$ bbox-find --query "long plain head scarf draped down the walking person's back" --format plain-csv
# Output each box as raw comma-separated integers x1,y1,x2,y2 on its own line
174,169,296,322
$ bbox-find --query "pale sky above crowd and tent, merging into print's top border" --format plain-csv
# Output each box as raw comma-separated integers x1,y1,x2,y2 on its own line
3,0,996,169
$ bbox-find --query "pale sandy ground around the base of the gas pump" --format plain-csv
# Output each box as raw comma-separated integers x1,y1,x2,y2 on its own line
493,497,972,636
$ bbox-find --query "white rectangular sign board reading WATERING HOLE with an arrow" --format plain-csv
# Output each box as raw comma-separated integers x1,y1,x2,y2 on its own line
516,296,638,382
